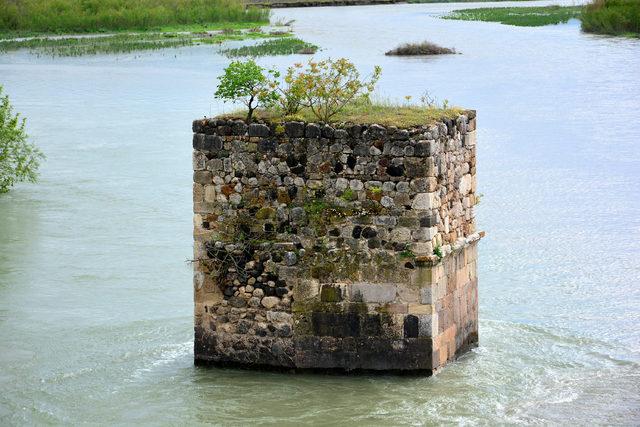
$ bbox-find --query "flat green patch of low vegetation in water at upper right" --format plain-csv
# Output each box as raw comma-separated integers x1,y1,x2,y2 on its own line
443,6,582,27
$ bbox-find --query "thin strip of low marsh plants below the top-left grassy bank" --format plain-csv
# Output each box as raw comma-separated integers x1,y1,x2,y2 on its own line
0,30,283,56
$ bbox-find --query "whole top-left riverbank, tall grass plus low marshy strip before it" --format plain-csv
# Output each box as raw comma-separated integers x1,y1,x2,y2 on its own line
0,0,280,56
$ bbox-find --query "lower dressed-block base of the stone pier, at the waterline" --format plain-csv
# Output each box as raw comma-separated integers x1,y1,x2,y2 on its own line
194,240,478,375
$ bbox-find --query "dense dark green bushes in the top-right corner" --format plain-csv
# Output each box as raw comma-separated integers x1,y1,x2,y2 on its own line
581,0,640,37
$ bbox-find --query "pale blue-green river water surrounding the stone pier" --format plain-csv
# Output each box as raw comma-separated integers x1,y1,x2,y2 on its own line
0,2,640,425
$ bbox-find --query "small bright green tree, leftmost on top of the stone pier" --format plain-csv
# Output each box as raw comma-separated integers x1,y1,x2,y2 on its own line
215,59,278,122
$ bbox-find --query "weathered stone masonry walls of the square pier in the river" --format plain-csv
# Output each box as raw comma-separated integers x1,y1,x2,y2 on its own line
193,111,481,373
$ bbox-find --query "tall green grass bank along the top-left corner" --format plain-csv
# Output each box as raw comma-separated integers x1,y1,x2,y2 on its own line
0,0,269,33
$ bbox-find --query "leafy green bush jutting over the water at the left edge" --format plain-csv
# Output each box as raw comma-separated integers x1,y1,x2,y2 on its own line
0,86,44,193
